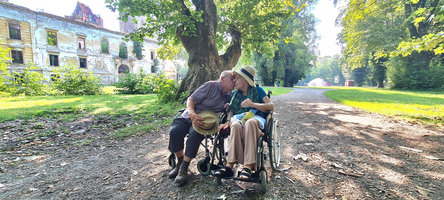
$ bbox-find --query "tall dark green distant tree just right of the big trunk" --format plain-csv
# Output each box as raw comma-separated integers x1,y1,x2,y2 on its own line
253,0,318,87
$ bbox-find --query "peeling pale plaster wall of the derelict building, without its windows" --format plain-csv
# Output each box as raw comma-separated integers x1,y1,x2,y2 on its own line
0,2,158,84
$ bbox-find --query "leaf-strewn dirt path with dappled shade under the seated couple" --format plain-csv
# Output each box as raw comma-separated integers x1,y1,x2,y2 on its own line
0,89,444,199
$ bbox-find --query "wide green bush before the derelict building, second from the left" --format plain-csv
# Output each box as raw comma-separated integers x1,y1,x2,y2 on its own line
52,63,103,95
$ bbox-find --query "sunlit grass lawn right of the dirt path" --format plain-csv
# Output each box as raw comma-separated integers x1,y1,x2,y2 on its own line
324,87,444,126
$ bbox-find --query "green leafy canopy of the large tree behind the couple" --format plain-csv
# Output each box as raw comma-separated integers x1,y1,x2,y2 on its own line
105,0,295,59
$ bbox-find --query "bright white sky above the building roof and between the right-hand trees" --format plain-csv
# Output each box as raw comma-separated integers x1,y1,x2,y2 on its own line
9,0,341,56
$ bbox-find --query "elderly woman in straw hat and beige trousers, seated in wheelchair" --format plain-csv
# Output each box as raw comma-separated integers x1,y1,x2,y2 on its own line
212,65,274,179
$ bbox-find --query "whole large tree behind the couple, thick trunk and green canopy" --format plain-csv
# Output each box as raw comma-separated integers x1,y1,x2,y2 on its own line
106,0,295,98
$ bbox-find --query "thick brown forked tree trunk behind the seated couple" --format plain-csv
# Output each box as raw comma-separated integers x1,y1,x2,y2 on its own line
175,0,242,100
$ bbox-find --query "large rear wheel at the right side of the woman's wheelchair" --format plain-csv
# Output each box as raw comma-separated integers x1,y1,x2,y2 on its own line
270,119,281,170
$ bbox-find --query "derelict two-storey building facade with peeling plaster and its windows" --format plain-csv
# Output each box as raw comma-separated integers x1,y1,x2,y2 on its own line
0,2,163,84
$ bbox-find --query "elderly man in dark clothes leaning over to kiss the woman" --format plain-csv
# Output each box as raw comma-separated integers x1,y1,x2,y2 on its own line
168,70,234,186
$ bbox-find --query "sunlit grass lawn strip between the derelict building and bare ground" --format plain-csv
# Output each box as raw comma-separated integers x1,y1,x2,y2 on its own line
0,94,180,122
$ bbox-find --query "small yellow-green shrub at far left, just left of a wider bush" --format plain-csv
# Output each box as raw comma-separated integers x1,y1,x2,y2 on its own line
11,63,49,96
